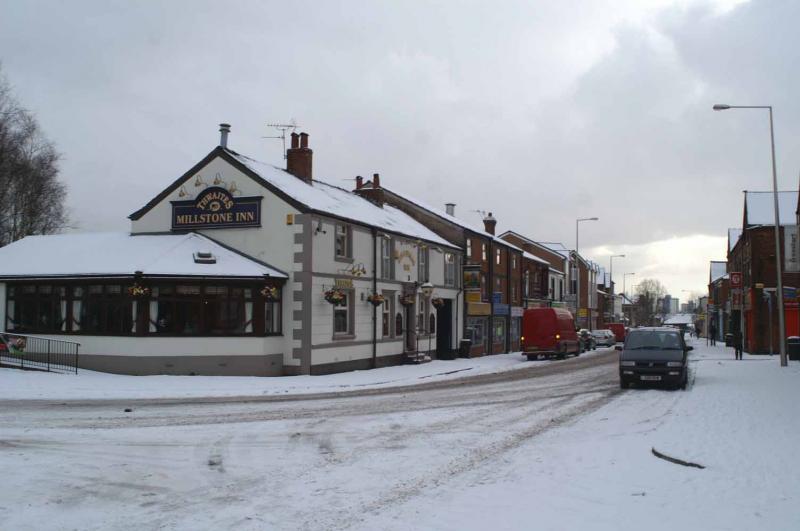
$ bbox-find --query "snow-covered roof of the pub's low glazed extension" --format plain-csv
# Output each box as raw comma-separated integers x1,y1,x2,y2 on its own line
0,232,287,278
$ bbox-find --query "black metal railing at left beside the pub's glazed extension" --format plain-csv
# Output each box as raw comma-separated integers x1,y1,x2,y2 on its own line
0,332,80,374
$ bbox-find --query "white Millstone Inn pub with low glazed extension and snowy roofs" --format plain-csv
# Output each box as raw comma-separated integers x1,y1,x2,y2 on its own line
0,124,466,376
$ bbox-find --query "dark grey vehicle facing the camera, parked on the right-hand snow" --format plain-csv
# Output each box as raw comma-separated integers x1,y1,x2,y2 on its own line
616,327,692,389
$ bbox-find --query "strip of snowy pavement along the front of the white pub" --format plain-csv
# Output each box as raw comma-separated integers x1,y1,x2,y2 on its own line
0,349,608,400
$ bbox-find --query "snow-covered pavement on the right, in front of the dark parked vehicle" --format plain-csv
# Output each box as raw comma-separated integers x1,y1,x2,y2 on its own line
362,340,800,530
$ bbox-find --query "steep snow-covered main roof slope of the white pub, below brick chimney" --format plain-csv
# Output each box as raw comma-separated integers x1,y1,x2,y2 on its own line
226,150,454,247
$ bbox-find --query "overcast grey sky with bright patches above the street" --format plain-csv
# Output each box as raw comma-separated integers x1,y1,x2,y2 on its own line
0,0,800,299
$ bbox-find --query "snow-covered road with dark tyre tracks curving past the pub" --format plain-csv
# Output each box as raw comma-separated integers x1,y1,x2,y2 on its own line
0,351,619,529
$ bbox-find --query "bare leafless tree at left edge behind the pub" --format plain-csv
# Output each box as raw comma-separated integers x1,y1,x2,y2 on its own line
0,66,67,245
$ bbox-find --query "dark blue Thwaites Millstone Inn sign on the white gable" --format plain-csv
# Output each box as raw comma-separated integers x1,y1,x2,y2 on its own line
172,186,263,230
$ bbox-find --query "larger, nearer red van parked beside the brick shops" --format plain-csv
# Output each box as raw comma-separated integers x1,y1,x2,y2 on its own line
522,308,581,360
